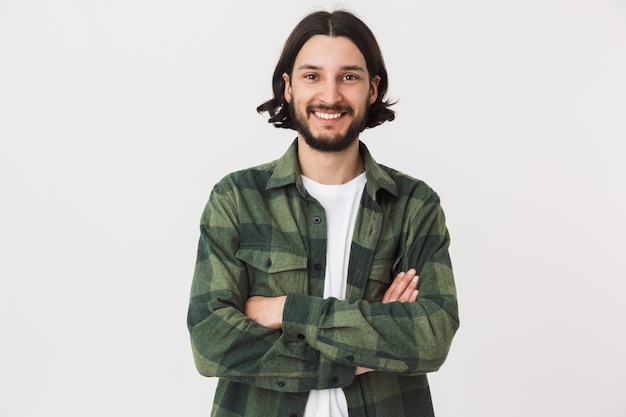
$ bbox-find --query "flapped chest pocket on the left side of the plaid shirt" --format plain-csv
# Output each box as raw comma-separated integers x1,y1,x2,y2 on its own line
235,247,308,297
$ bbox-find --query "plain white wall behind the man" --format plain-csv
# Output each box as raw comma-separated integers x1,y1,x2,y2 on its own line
0,0,626,417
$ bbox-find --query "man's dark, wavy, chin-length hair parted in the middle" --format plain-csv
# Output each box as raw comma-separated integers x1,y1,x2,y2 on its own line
256,10,396,130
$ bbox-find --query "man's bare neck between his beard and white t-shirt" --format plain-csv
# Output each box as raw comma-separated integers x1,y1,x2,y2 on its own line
298,138,364,185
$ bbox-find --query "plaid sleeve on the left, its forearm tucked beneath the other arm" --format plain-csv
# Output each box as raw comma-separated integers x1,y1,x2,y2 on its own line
187,180,354,392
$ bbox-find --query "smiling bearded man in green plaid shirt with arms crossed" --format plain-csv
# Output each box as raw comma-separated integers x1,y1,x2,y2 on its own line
188,11,458,417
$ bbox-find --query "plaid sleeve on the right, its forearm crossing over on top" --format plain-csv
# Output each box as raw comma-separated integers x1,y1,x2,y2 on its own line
283,195,459,375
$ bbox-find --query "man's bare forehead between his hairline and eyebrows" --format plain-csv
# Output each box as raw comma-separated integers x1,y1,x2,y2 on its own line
294,35,366,71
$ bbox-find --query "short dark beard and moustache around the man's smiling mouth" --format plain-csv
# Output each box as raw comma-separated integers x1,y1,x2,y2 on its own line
289,102,370,152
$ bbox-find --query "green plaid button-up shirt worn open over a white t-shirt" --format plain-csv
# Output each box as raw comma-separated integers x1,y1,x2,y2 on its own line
188,142,459,417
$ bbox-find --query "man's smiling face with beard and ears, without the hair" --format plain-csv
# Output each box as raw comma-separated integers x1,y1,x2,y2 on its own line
283,35,380,152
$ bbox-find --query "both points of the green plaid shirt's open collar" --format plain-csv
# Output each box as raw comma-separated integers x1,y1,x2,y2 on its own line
267,139,398,199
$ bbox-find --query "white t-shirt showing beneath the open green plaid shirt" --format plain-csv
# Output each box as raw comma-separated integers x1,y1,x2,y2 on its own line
302,173,366,417
